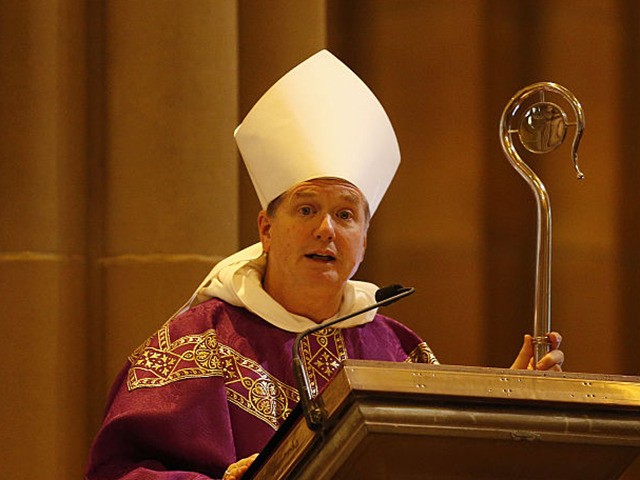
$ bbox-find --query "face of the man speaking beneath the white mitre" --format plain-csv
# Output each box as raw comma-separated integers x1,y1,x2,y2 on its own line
259,179,368,294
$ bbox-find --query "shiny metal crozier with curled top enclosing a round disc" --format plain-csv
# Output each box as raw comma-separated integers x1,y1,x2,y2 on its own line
500,82,584,368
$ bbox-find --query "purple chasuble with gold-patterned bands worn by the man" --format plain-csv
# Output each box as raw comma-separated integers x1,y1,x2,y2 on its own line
85,299,437,480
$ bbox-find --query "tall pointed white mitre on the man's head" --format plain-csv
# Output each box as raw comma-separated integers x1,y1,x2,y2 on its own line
235,50,400,215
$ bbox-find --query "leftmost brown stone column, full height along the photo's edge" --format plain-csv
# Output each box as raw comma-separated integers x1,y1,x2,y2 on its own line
0,0,87,480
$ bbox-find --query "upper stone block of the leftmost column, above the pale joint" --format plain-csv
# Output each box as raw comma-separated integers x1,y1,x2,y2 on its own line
0,0,87,253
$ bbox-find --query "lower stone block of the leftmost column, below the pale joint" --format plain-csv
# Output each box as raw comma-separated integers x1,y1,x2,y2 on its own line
0,256,90,480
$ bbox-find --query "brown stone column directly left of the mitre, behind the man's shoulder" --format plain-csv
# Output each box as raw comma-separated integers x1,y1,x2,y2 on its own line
93,0,238,396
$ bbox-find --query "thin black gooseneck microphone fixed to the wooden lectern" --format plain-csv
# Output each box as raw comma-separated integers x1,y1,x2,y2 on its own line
293,284,415,431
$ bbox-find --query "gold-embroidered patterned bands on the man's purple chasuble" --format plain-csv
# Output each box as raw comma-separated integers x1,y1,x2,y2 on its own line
127,322,438,430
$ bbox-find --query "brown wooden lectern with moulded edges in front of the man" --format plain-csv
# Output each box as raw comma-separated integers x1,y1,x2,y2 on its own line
243,360,640,480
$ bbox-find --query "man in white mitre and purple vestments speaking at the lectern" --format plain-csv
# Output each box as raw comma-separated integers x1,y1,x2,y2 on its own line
86,51,562,480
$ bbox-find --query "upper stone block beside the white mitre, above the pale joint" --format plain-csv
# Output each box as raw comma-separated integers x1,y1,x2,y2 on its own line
104,0,238,255
